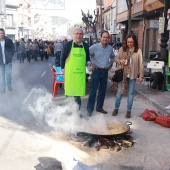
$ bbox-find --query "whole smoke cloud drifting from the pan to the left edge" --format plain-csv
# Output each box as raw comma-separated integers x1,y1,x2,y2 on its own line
0,82,121,135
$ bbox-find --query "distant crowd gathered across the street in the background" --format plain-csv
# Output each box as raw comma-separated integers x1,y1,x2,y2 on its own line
14,38,67,63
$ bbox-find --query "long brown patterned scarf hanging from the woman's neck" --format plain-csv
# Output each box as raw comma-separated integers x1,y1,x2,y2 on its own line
118,47,134,94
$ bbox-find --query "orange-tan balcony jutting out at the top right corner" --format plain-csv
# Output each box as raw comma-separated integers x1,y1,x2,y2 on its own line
144,0,164,12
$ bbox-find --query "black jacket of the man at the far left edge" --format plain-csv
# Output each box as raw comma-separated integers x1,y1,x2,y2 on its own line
0,37,15,64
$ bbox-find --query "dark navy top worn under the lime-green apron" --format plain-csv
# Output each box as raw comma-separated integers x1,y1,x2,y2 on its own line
60,40,90,69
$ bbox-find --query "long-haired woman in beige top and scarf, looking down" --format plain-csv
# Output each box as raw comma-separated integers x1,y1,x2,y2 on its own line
112,34,144,118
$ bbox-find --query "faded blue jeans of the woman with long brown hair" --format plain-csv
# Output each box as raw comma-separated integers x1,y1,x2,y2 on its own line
115,78,136,111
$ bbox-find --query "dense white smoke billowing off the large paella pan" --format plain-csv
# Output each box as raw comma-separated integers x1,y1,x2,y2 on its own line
28,89,123,134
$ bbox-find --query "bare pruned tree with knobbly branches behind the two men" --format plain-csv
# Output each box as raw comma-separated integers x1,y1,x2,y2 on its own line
81,10,99,45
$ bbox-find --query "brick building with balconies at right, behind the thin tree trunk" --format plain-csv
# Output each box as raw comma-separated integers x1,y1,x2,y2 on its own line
116,0,164,60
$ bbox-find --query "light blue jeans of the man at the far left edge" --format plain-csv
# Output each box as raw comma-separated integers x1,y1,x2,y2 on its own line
0,63,12,91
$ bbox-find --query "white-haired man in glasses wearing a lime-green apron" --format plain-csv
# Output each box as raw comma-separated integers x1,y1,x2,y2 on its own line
61,28,90,109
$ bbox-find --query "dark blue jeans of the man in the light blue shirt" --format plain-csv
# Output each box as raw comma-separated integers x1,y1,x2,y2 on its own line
86,70,108,112
